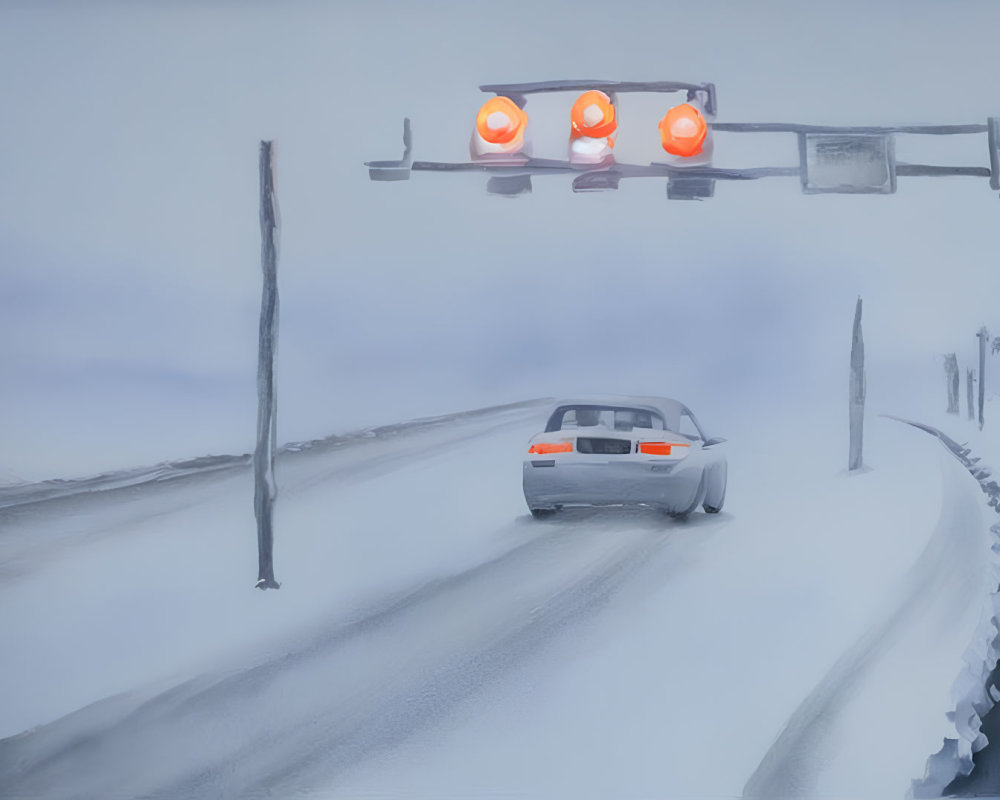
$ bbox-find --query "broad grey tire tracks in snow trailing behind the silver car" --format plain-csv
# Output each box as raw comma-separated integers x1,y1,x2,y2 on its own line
0,518,724,800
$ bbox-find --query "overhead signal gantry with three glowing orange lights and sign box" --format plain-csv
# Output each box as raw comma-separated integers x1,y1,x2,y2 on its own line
365,80,1000,200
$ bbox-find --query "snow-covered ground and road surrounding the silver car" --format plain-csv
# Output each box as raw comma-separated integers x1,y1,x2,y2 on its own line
0,396,1000,798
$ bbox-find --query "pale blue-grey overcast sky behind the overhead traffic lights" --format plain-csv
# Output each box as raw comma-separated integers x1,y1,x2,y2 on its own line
0,0,1000,481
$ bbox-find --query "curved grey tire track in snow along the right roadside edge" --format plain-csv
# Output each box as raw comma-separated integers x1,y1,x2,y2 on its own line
742,459,983,800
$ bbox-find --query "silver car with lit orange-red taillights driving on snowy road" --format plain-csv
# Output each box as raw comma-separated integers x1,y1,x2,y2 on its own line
524,397,727,518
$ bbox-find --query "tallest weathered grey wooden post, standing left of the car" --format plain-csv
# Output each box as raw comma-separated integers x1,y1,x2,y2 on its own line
253,142,280,589
